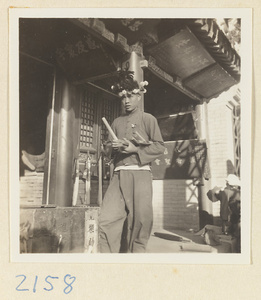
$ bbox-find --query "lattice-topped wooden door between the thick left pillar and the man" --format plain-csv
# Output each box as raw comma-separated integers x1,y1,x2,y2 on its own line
77,87,120,206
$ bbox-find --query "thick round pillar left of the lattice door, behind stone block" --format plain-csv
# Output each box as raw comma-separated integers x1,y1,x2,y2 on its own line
43,72,78,207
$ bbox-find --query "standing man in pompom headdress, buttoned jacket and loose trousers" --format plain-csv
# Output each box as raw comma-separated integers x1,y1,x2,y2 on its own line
99,71,165,253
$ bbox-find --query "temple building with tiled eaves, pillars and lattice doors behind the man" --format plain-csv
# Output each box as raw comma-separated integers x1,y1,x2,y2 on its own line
19,18,240,253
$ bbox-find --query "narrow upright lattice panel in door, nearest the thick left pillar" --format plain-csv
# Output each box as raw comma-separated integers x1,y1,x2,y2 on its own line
80,90,96,148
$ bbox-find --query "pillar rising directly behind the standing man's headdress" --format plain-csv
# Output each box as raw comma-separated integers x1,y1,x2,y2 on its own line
122,51,144,111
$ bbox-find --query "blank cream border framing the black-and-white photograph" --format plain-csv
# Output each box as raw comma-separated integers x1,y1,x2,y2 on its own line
9,8,252,264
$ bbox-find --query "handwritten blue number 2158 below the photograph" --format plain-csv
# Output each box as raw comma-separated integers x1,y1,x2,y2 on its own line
16,274,76,294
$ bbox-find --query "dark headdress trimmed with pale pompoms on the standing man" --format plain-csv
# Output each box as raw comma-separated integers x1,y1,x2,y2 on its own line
111,70,149,97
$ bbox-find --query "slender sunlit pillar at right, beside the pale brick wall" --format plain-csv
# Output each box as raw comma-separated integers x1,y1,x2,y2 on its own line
196,103,213,228
